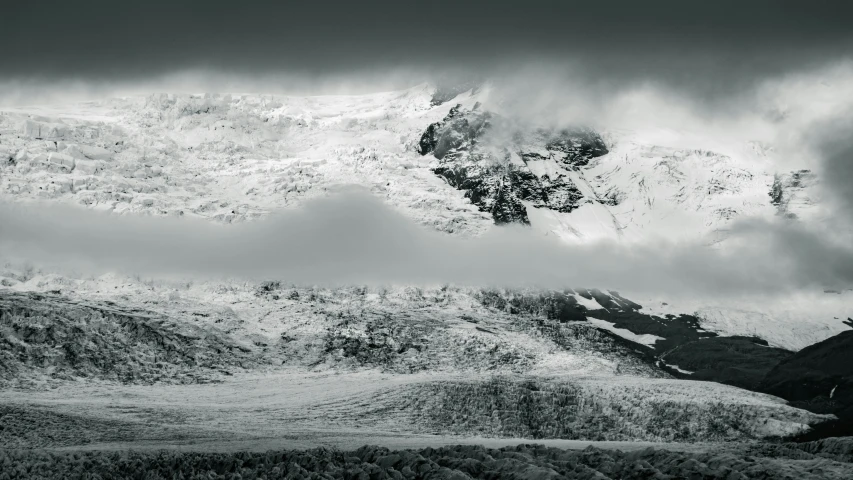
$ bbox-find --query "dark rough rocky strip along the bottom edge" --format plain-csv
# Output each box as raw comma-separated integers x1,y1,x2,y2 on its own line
0,444,853,480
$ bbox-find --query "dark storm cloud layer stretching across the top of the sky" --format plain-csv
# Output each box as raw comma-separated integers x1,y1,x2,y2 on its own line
5,0,853,95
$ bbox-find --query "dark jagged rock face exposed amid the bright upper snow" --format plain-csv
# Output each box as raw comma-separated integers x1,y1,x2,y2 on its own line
418,105,607,224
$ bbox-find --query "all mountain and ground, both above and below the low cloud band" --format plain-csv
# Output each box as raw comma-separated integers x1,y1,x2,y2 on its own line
0,85,853,479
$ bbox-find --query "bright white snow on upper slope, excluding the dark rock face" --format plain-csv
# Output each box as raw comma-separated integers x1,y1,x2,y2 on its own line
0,85,816,248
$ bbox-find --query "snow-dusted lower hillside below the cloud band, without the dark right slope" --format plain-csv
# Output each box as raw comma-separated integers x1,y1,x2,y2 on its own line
0,283,829,447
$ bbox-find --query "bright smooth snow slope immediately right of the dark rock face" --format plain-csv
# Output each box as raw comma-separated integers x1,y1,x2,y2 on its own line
581,131,788,239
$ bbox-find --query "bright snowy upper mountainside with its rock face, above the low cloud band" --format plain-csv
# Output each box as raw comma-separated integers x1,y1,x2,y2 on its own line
0,85,817,241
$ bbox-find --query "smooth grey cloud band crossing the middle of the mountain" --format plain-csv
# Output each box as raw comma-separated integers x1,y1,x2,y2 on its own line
0,190,853,296
